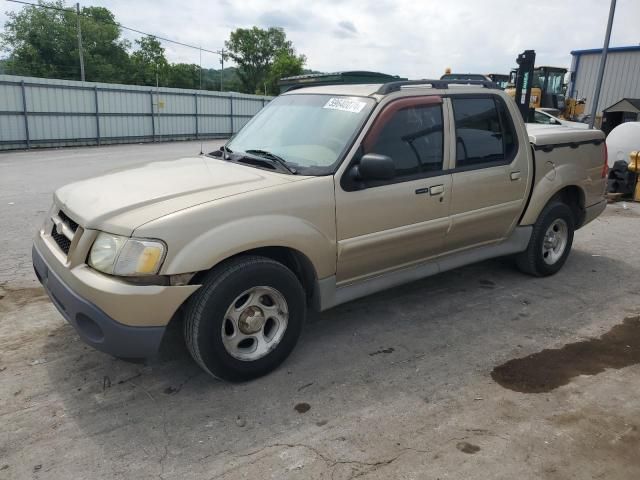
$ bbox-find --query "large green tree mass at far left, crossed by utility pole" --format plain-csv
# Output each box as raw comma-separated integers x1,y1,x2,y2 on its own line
0,0,129,82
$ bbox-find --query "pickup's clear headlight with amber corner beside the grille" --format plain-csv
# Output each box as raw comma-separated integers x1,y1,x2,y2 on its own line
88,233,167,276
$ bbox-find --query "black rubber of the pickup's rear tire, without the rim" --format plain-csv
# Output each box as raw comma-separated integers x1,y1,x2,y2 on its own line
516,200,575,277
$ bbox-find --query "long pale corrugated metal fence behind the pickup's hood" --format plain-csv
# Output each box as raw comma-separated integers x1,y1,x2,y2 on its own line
0,75,271,150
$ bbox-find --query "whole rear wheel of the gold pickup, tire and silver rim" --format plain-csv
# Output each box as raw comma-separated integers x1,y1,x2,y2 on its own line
516,201,575,277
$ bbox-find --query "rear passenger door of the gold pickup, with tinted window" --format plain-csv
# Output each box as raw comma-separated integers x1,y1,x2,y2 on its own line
445,94,532,251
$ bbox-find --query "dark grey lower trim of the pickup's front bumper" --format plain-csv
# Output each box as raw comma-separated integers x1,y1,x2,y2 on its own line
31,246,166,358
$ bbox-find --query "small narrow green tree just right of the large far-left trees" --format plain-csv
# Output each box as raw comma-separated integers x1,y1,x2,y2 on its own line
131,37,169,86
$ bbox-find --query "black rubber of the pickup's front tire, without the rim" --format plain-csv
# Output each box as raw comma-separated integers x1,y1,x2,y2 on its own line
184,256,306,382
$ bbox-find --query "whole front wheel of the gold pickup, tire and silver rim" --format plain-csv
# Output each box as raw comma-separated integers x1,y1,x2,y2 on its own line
184,257,306,381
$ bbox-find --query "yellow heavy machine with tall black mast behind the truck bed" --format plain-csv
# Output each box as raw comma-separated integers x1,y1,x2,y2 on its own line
505,50,585,120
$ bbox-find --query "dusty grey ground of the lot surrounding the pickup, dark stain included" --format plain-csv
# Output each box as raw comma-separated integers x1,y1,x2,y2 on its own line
0,143,640,480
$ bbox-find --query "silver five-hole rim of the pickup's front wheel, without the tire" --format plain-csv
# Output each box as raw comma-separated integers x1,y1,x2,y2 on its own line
221,286,289,362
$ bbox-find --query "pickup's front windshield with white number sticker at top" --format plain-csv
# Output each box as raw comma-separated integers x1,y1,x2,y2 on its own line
227,94,375,175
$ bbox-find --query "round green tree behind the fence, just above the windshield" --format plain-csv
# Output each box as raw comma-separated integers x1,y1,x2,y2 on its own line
225,27,306,93
